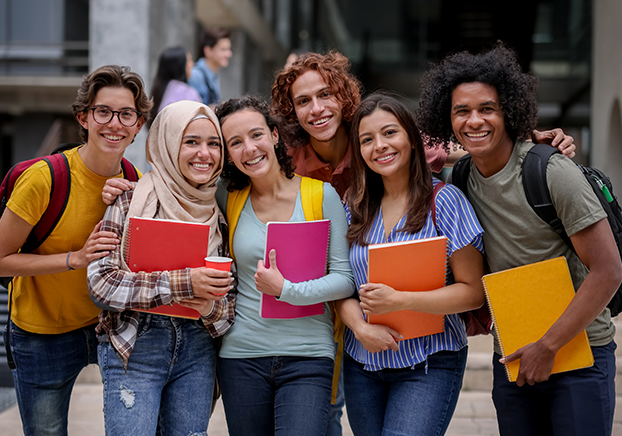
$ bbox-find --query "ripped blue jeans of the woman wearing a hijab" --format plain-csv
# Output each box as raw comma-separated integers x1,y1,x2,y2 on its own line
98,314,217,436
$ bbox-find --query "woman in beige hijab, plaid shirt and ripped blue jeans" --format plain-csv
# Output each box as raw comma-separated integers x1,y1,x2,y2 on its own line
88,101,236,436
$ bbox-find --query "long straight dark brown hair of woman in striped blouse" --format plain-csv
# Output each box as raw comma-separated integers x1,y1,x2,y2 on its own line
346,92,433,246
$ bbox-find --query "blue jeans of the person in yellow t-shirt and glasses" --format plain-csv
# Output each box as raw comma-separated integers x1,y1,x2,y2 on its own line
5,322,97,436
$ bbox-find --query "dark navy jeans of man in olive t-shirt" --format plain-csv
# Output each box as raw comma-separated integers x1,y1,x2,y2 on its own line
492,341,616,436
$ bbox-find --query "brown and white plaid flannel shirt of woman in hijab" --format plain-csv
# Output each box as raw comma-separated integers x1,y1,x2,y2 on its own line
88,190,237,365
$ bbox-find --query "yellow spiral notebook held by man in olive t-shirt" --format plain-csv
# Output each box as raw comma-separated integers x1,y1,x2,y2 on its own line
482,256,594,382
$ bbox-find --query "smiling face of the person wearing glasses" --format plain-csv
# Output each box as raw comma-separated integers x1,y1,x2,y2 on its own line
76,86,145,156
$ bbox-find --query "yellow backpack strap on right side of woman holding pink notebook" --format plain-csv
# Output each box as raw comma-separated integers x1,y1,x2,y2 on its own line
300,177,345,404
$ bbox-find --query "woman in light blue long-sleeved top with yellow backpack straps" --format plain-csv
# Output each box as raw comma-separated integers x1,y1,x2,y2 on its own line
216,97,354,436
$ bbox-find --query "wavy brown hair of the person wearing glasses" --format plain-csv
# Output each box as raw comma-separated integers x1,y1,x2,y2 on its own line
71,65,153,142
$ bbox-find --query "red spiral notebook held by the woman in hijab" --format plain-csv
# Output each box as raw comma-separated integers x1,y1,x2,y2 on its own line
124,217,209,319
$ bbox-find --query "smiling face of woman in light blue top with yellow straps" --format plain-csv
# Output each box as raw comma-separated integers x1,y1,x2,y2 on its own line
221,109,280,179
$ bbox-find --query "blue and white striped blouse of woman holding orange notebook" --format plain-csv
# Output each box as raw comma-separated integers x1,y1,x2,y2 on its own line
344,179,484,371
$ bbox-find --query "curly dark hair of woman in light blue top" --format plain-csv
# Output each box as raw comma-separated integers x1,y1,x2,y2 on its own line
215,95,296,192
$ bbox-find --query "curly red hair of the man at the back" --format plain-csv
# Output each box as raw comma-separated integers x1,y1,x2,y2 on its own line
272,51,363,147
